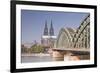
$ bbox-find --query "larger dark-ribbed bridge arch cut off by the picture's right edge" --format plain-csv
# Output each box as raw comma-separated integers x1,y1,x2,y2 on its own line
73,15,90,49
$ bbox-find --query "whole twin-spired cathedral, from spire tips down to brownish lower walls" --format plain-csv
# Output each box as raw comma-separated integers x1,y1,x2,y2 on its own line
41,21,56,48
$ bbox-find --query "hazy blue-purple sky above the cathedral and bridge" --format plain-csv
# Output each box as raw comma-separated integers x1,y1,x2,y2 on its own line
21,10,89,43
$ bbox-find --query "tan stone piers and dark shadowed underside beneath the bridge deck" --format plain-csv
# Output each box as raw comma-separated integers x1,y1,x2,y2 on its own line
52,49,90,61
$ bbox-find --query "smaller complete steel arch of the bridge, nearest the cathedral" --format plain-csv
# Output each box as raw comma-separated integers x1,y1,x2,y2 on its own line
56,28,75,48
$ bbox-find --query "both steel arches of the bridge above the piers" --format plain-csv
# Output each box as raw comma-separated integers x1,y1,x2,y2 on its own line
55,15,90,51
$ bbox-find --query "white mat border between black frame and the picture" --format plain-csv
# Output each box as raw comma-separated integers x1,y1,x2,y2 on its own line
16,4,94,69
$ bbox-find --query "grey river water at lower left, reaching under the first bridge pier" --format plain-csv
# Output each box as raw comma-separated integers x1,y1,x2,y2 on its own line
21,55,64,63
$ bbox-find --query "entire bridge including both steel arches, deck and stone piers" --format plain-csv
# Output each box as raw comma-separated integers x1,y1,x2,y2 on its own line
53,15,90,60
